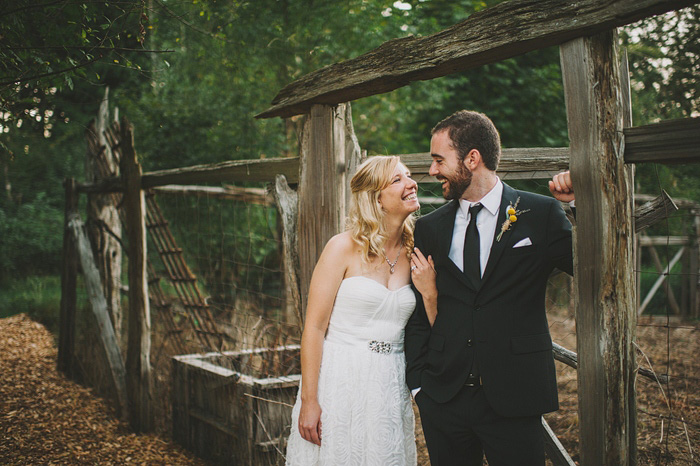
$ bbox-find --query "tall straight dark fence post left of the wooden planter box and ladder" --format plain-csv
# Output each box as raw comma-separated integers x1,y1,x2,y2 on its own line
120,118,153,432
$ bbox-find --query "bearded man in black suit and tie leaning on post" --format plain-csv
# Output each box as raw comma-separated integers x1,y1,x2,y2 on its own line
405,110,574,466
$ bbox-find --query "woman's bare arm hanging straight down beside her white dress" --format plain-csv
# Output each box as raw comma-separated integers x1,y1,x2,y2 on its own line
299,233,348,445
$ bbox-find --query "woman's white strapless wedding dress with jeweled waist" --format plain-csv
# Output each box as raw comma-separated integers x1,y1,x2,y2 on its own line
287,276,416,466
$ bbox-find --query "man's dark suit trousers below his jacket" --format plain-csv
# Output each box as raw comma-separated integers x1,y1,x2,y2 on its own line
416,387,544,466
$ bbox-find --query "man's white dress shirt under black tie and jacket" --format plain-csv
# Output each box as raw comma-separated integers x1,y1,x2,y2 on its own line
449,178,503,277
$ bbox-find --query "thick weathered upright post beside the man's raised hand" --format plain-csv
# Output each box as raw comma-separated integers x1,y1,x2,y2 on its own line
560,31,636,466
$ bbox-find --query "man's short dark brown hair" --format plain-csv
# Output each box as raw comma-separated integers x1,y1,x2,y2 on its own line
430,110,501,171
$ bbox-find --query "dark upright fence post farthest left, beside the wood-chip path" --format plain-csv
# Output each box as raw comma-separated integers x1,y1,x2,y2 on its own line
57,178,79,378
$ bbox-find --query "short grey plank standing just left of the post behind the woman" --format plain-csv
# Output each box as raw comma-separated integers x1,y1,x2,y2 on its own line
272,175,304,335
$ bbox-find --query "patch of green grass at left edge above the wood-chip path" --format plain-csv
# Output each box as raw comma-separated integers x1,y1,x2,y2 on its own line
0,276,61,334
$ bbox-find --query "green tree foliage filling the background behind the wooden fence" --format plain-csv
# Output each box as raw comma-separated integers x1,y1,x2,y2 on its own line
0,0,700,318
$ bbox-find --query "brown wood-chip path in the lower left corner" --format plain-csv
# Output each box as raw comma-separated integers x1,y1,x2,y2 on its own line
0,314,206,465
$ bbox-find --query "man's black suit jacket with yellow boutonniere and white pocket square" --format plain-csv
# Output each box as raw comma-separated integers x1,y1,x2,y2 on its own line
405,183,573,417
